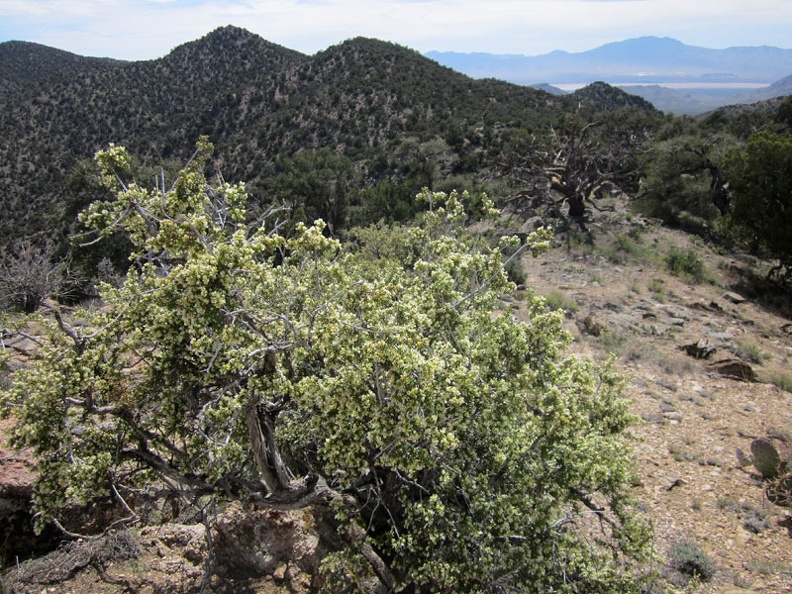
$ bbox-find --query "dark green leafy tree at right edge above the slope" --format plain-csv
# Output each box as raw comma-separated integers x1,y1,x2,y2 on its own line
723,132,792,274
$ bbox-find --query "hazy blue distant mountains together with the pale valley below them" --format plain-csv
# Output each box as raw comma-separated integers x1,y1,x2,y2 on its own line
426,37,792,113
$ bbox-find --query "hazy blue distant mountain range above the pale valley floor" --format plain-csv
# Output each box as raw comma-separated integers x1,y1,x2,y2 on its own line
425,37,792,85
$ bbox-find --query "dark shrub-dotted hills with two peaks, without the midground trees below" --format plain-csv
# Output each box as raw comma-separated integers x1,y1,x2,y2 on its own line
7,27,653,244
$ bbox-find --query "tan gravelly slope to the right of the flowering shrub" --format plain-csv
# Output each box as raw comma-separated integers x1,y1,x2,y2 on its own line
512,210,792,594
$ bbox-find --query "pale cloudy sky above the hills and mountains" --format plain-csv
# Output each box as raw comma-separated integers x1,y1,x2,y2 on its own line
0,0,792,60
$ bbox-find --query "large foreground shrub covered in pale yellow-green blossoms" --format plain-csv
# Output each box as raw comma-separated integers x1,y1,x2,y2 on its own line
0,140,649,592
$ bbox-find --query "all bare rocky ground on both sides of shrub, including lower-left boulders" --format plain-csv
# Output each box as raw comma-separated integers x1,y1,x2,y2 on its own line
0,206,792,594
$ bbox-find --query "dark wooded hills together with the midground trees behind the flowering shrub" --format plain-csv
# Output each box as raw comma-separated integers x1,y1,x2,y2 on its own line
0,27,789,286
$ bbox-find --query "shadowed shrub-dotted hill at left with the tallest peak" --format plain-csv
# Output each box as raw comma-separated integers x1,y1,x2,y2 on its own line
0,27,304,237
